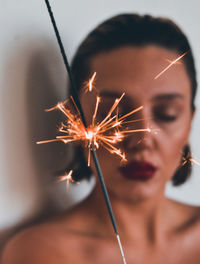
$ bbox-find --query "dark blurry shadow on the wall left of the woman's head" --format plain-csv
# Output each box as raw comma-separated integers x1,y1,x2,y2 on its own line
26,36,73,210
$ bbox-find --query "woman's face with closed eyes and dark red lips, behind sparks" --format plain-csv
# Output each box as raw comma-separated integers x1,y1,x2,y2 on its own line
81,45,192,201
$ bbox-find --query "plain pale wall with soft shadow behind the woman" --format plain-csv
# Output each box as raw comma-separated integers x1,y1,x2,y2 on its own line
0,0,200,244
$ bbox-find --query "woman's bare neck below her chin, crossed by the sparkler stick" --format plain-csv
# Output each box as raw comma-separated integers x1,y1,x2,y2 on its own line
86,186,172,243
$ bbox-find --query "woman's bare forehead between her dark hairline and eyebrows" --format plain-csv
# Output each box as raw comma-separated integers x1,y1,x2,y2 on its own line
91,45,191,99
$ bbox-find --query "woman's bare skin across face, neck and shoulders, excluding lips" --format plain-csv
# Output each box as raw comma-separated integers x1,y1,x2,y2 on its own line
1,46,200,264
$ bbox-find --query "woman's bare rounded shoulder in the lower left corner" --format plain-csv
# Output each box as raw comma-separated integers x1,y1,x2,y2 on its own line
0,212,81,264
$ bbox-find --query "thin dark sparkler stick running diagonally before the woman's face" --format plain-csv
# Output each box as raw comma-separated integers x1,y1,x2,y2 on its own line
45,0,126,264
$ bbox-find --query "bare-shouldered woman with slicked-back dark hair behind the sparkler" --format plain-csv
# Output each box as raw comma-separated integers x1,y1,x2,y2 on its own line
2,14,200,264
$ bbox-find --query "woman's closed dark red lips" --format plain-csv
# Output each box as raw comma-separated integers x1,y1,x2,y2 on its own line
119,161,157,181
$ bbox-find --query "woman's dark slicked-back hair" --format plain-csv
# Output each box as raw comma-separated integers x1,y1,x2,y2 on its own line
69,14,197,185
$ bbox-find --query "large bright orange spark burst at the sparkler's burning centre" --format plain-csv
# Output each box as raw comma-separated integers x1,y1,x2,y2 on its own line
37,73,151,166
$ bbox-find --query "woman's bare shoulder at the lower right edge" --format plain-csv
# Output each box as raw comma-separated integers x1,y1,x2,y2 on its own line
167,199,200,263
